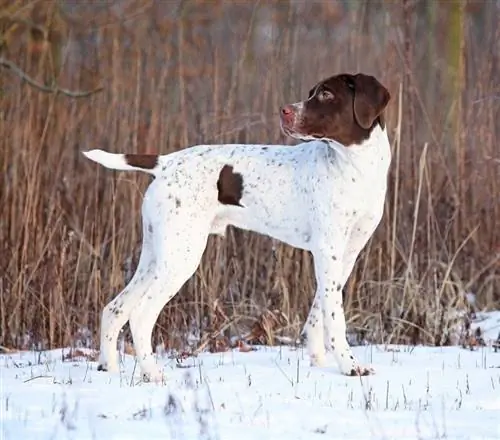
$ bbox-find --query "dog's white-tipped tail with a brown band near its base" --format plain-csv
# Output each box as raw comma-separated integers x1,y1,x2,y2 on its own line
83,150,160,176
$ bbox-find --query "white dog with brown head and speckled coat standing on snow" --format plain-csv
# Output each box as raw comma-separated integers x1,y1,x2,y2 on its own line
83,73,391,381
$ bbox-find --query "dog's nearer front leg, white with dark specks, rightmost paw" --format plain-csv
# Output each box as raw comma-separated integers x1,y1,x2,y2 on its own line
313,246,371,376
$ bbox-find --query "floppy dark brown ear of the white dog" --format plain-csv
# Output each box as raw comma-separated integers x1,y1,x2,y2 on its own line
352,73,391,129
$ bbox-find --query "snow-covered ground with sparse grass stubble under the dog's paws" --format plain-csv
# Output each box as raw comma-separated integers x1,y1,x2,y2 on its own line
0,312,500,440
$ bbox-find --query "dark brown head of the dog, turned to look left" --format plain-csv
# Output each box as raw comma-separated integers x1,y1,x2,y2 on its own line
280,73,391,147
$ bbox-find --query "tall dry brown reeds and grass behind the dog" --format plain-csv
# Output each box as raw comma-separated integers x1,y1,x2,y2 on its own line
0,0,500,349
